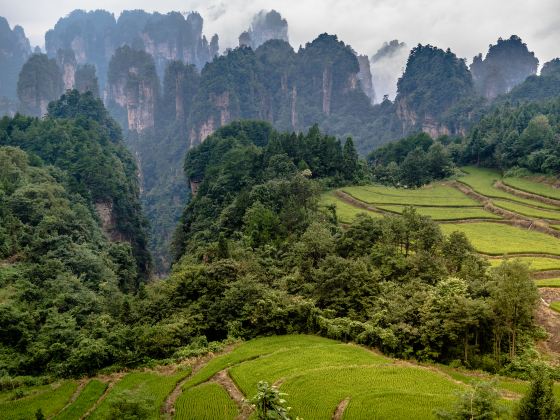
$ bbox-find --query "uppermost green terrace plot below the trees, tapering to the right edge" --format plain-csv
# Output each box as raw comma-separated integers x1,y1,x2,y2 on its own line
457,166,556,209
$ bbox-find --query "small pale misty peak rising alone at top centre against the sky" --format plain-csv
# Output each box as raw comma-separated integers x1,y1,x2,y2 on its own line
239,10,289,49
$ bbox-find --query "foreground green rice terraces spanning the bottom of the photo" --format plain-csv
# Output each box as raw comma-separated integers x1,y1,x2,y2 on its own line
0,335,560,420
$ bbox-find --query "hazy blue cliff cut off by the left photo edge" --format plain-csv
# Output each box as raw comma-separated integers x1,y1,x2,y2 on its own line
0,17,31,102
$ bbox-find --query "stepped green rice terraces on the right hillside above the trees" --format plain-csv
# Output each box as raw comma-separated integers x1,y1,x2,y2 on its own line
322,167,560,351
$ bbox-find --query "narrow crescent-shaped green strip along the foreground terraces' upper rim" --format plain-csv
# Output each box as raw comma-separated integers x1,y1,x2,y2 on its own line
183,335,338,390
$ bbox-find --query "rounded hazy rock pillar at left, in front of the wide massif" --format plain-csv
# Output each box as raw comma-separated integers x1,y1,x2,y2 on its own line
17,54,64,116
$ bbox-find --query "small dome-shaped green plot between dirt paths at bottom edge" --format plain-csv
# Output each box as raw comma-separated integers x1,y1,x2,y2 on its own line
175,382,238,420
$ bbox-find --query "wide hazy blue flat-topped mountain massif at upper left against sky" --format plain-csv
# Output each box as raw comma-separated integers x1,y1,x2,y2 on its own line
45,10,219,88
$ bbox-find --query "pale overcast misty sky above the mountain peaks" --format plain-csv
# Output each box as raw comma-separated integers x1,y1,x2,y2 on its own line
0,0,560,64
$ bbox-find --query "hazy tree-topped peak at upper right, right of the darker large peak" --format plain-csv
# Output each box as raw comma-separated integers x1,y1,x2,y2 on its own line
470,35,539,99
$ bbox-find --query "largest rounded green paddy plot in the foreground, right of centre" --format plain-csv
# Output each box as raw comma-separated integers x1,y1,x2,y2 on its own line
280,365,461,419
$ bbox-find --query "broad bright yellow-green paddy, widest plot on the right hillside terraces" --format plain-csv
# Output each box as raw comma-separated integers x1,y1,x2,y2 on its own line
441,222,560,255
